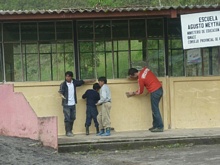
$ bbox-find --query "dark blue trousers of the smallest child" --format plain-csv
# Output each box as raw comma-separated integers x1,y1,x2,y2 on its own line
85,105,99,127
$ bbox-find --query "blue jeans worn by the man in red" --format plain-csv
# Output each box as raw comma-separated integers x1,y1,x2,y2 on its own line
150,87,164,128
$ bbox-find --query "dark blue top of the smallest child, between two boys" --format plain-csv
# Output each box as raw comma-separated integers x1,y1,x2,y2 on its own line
82,89,100,107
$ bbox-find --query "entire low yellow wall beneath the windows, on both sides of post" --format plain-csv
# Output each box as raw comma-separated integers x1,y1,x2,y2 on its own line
11,77,220,135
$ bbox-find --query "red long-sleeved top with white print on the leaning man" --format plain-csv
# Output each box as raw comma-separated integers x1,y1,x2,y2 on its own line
136,68,162,94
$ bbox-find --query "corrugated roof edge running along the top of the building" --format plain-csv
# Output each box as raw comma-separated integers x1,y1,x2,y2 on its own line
0,5,220,15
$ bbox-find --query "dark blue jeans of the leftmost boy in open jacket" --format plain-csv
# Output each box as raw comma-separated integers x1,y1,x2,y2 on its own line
63,105,76,132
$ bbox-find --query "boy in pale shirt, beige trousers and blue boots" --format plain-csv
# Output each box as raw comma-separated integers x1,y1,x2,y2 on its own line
96,77,111,136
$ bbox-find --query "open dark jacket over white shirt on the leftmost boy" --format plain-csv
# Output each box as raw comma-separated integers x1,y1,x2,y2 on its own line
59,79,85,106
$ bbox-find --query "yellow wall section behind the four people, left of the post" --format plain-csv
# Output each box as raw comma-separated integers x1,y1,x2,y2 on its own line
12,79,166,135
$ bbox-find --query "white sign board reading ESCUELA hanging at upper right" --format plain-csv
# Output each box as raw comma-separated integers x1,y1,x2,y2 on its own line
181,11,220,49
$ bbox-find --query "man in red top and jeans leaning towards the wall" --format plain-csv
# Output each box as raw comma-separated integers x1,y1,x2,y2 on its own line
126,67,164,132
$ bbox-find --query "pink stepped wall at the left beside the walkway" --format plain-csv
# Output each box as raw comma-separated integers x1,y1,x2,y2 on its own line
0,84,58,149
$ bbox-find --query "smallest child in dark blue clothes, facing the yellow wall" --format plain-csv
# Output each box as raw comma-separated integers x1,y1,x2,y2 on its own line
82,83,101,135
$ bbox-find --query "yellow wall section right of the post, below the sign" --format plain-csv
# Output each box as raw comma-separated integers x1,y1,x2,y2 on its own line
170,77,220,128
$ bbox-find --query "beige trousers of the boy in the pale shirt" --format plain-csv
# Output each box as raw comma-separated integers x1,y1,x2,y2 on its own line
97,102,112,129
